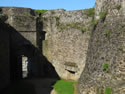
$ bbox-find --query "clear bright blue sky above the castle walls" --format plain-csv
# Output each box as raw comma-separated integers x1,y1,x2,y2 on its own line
0,0,95,10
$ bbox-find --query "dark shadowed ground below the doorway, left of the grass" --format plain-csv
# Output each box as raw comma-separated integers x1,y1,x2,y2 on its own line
2,79,56,94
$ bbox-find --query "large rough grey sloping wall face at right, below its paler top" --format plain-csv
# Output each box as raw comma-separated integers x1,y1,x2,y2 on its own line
78,16,125,94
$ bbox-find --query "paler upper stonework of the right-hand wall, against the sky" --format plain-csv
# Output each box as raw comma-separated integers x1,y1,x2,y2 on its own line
95,0,125,19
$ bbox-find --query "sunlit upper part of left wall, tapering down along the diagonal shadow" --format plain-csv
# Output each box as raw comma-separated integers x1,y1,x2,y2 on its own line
1,7,37,46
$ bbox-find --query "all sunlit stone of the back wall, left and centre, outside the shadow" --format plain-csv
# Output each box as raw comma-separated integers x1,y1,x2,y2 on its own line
1,7,93,80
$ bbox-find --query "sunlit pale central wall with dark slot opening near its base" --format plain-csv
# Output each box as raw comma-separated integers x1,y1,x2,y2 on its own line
43,10,92,80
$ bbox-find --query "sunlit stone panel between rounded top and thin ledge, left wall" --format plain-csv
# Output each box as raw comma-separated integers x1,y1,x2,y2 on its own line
6,15,36,32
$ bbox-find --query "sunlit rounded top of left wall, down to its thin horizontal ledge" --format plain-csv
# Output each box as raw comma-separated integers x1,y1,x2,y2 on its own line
0,7,36,31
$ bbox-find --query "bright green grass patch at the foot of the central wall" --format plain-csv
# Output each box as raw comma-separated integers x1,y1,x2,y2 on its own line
53,80,76,94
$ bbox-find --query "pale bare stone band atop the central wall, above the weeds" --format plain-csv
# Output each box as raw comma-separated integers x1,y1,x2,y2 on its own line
44,9,92,24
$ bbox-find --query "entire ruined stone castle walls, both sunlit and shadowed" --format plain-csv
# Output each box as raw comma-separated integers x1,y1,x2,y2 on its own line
0,0,125,94
